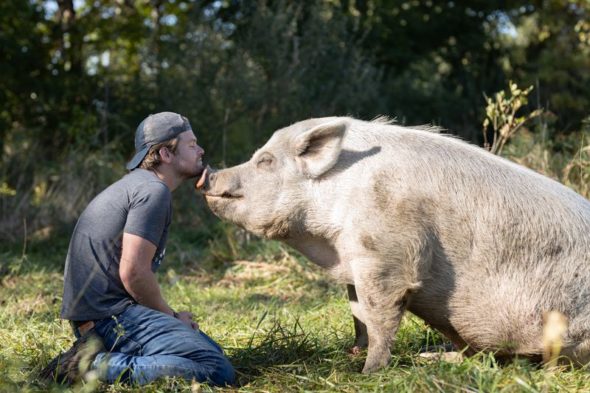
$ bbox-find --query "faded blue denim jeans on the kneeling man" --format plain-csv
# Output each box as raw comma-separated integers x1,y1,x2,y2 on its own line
92,304,235,386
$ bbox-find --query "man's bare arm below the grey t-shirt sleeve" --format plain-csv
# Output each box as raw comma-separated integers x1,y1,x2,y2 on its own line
119,233,197,328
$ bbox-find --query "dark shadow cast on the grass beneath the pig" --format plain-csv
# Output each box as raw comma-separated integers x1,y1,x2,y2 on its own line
224,306,538,386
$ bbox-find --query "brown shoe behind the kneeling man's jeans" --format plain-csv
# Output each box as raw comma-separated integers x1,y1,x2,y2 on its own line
39,331,105,385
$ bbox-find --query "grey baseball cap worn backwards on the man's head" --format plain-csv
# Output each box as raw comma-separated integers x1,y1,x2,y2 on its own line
127,112,192,170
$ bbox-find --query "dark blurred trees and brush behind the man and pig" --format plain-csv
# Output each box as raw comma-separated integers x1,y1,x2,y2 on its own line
0,0,590,243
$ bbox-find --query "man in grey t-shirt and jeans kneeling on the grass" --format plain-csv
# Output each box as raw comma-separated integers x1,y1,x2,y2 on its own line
42,112,235,386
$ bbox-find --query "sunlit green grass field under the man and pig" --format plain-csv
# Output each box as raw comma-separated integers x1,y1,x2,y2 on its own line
0,227,590,392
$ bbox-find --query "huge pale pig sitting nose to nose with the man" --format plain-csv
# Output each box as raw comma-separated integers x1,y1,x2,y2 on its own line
200,117,590,373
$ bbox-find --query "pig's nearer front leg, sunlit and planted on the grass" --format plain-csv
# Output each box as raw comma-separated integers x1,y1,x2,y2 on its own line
354,260,411,374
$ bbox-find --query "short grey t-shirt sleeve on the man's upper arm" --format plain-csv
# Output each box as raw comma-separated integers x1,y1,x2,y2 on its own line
124,182,171,247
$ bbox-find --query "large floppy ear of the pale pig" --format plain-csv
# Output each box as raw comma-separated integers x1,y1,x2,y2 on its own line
295,120,348,179
